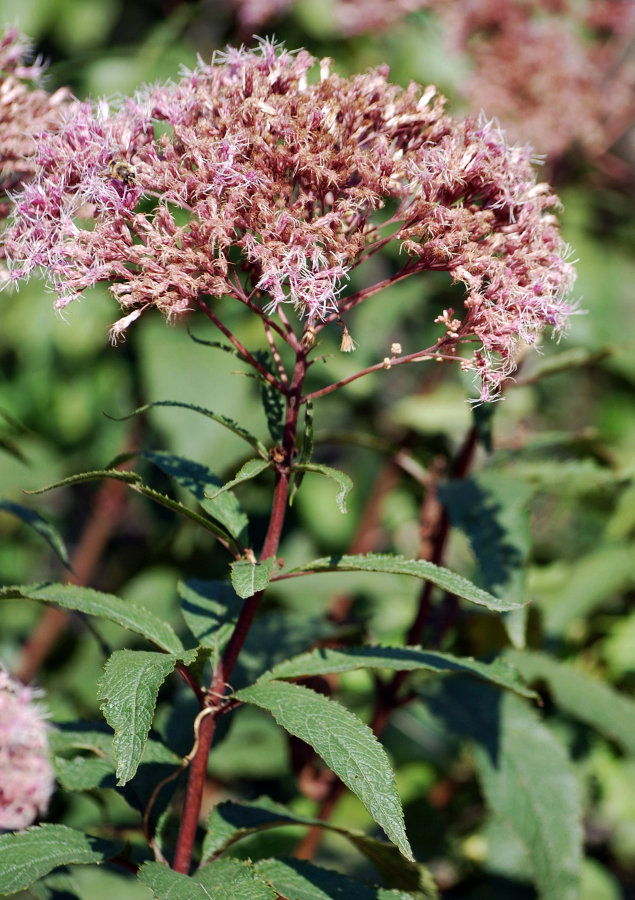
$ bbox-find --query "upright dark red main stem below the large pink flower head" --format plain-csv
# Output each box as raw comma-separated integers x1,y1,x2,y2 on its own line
173,348,307,874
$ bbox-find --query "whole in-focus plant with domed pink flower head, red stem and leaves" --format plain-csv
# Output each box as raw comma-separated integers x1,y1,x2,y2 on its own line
0,35,596,900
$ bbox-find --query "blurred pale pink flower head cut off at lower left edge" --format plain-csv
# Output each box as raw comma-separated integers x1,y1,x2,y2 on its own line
0,669,54,831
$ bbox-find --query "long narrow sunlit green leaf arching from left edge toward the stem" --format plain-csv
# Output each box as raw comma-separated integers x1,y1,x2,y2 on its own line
0,584,187,658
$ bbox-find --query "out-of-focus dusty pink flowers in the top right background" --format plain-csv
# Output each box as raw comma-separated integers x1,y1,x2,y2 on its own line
233,0,635,157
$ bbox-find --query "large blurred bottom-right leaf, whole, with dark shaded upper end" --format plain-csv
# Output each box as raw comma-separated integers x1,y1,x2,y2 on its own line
423,678,582,900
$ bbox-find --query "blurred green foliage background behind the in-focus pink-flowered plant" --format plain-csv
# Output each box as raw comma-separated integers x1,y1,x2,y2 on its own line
0,0,635,900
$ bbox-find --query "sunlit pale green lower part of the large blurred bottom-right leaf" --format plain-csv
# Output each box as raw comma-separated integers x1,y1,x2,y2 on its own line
475,694,582,900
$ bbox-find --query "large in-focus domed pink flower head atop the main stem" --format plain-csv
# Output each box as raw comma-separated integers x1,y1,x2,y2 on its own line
8,42,573,399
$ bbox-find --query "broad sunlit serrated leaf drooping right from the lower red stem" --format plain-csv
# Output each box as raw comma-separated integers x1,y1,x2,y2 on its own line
235,681,412,859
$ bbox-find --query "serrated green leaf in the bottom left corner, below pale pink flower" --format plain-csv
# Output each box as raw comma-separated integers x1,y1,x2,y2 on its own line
0,825,120,895
